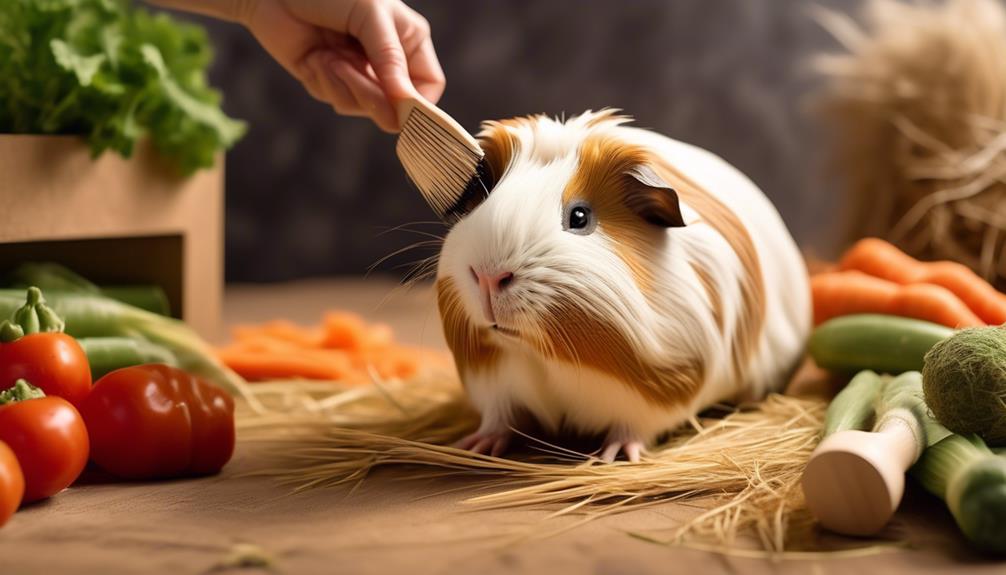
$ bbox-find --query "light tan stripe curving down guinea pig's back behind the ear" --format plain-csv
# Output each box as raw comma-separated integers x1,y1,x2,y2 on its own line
652,159,765,377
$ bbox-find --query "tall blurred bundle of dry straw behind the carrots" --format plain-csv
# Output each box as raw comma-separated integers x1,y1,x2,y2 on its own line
813,0,1006,290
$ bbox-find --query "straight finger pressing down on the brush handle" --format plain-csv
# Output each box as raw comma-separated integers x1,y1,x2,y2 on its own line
350,4,415,101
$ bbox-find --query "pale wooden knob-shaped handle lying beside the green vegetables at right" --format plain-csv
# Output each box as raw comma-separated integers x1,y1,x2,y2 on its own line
803,419,918,536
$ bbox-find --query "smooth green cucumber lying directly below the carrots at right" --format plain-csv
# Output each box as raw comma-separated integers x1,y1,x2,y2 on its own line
808,314,954,374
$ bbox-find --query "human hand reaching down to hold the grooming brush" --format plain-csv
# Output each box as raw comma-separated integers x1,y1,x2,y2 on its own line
153,0,445,132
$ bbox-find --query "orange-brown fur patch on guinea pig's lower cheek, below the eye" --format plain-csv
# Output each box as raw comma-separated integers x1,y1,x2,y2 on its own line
538,305,705,406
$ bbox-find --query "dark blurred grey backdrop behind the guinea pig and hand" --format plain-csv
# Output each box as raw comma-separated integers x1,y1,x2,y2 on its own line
179,0,858,281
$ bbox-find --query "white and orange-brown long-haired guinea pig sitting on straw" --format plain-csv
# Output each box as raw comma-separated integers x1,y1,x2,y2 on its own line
437,111,811,461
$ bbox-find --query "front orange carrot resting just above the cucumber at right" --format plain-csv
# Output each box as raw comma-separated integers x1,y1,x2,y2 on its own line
811,270,985,328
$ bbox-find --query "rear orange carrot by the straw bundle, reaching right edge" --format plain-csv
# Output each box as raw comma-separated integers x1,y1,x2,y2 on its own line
839,237,1006,325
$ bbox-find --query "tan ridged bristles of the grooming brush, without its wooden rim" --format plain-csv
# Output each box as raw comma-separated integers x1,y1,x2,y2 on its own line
395,108,483,220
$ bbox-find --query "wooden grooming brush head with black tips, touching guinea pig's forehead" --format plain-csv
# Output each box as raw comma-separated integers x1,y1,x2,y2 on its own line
395,99,491,225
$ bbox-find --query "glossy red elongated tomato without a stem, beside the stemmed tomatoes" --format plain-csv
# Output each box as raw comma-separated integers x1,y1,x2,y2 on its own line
80,365,234,480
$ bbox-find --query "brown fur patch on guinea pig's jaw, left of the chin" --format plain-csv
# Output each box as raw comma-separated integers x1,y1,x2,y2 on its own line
437,277,499,381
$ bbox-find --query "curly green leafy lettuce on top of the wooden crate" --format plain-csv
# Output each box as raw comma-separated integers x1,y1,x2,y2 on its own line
0,0,244,174
